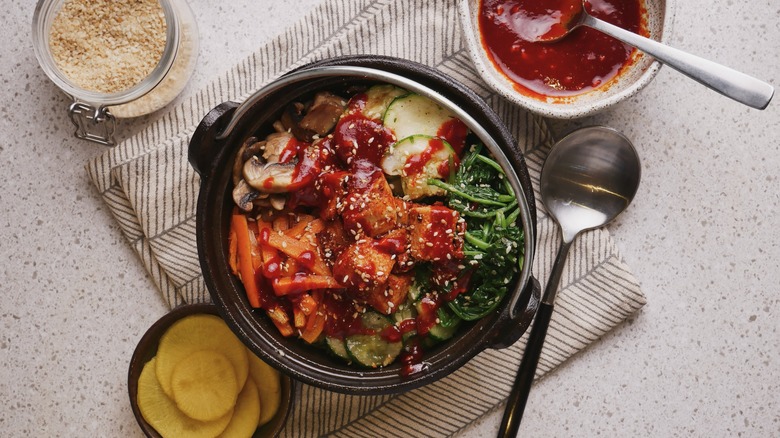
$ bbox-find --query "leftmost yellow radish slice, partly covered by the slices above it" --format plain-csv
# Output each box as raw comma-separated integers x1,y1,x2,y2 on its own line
136,359,233,438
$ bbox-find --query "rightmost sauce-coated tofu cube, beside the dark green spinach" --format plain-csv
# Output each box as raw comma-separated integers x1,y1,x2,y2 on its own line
408,205,463,261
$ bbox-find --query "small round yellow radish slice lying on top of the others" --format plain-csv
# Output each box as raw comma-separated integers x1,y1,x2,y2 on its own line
171,350,241,421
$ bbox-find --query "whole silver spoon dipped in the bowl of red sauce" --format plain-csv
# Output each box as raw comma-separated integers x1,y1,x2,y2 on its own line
528,0,775,110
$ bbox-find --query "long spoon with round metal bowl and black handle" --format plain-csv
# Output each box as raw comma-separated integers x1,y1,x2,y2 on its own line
498,126,642,437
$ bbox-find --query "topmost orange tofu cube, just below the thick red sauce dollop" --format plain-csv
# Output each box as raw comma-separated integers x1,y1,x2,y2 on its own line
343,174,406,237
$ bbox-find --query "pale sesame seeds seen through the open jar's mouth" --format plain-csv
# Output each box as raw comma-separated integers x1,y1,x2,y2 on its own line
49,0,166,93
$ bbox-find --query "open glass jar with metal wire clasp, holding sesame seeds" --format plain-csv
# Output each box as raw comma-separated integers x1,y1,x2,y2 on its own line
32,0,198,146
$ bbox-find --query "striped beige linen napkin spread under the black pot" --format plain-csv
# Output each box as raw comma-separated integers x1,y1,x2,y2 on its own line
87,0,645,437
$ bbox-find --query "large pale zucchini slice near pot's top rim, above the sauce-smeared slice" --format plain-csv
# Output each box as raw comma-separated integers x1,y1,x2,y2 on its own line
382,93,455,140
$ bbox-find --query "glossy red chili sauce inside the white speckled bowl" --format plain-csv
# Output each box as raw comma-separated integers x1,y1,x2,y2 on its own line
479,0,647,100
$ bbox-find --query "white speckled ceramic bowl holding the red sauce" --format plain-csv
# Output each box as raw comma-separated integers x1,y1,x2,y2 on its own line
458,0,674,119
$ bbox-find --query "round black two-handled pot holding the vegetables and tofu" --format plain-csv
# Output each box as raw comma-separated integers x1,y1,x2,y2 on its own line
189,55,539,395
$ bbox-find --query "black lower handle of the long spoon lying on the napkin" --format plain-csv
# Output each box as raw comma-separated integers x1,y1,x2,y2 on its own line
498,303,553,438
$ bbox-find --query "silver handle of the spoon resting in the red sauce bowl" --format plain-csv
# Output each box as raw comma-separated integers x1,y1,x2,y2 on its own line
581,14,775,110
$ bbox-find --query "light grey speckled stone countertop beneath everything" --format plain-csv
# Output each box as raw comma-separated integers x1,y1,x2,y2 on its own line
0,0,780,437
